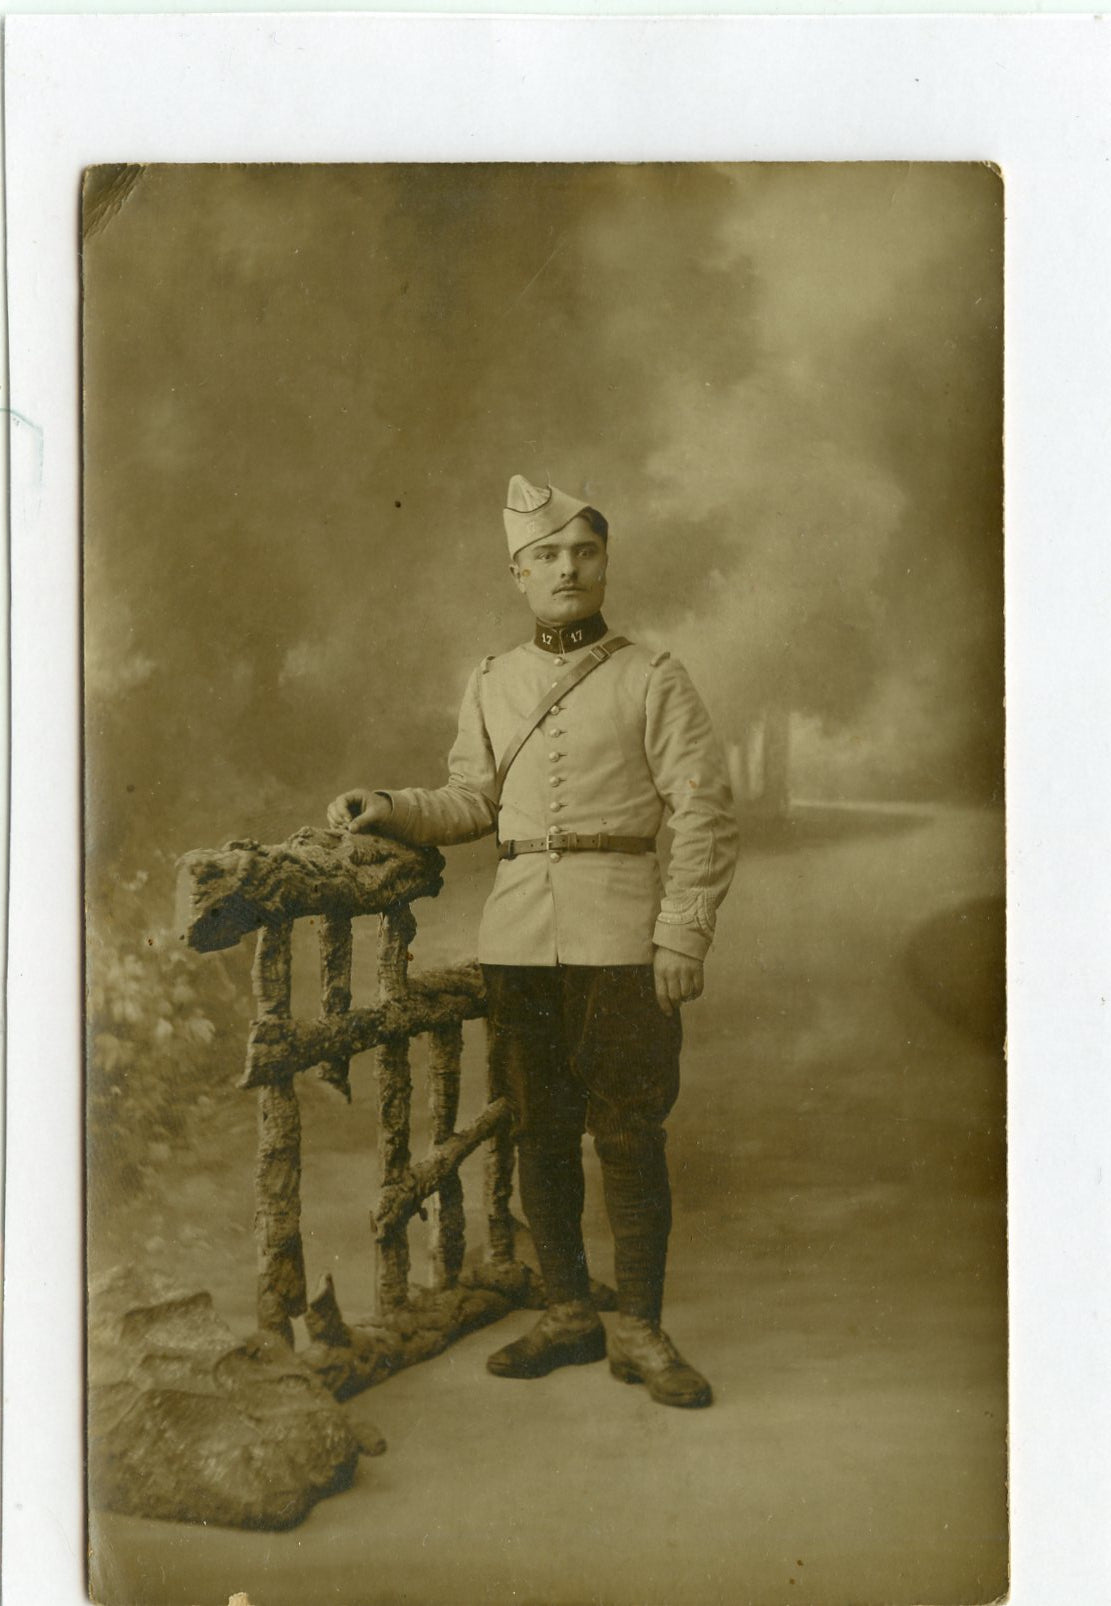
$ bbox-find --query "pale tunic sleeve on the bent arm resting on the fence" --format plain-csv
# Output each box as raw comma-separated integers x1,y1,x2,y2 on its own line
375,670,498,846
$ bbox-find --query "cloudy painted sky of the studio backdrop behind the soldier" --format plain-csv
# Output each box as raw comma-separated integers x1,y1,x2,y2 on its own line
83,164,1002,892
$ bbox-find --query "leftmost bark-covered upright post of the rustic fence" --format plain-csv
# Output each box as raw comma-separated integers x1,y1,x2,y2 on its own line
252,920,305,1344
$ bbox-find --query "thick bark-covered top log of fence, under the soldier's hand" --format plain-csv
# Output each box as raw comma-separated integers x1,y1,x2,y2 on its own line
177,825,443,954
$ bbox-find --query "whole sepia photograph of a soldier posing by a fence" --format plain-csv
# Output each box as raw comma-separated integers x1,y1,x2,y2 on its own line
80,161,1010,1606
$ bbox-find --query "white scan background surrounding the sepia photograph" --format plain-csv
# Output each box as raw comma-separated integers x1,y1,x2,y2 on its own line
3,14,1111,1606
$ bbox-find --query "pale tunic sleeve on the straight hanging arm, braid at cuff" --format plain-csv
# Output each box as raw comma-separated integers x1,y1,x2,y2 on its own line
645,658,737,959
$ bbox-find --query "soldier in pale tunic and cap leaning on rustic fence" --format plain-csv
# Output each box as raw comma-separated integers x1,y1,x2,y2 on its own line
328,475,737,1407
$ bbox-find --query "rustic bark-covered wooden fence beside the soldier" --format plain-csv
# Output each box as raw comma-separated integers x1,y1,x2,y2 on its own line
178,827,543,1396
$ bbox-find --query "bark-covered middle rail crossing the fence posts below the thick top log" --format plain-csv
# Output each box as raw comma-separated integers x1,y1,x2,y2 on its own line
239,965,486,1087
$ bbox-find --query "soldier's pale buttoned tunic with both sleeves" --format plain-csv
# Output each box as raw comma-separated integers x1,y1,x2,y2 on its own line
384,631,737,965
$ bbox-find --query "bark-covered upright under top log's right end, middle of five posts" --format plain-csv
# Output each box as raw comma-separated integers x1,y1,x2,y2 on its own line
374,904,416,1317
